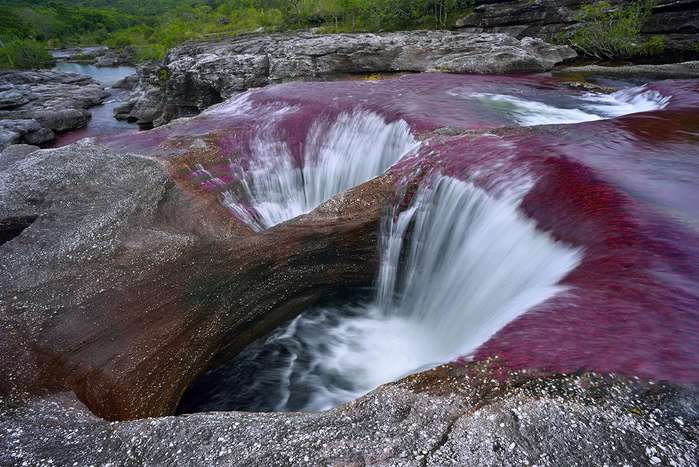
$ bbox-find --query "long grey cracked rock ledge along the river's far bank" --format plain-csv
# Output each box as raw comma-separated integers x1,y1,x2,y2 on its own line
115,31,575,127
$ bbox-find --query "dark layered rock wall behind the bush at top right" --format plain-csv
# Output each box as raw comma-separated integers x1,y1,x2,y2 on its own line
456,0,699,61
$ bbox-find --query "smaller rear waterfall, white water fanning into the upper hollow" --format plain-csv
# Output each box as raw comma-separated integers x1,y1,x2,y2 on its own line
223,111,418,231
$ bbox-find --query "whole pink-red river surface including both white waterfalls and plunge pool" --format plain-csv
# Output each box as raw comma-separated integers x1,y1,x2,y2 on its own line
98,74,699,413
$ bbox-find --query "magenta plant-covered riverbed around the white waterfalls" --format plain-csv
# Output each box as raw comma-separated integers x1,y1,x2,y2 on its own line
101,74,699,384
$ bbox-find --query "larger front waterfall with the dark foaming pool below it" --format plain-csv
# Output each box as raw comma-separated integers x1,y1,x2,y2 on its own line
181,176,581,412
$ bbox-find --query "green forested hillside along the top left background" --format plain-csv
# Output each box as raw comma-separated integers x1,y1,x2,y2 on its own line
0,0,473,68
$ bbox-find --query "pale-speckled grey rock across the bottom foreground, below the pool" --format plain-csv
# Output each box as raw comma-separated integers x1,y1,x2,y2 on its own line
0,365,699,466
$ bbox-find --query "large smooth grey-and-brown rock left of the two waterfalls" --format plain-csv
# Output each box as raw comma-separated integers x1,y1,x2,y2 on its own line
0,143,393,420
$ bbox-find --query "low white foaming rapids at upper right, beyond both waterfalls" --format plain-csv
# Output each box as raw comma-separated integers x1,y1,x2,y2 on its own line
470,86,670,126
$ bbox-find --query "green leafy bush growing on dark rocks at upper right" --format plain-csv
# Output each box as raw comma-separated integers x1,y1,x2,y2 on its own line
571,0,664,59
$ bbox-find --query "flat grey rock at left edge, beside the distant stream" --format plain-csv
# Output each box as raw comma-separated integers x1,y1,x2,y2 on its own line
0,71,109,151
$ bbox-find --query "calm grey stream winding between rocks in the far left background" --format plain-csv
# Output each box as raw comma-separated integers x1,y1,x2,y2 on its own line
51,63,138,147
